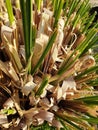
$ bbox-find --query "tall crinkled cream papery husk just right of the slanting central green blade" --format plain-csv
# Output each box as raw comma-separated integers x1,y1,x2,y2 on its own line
43,18,64,73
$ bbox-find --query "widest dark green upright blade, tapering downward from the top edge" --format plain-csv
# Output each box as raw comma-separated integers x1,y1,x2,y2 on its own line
20,0,33,62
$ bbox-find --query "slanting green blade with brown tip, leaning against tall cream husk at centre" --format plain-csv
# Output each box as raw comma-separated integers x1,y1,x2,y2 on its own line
32,31,57,75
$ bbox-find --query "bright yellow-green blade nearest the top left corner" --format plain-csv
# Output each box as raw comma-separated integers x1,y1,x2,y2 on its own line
5,0,14,26
